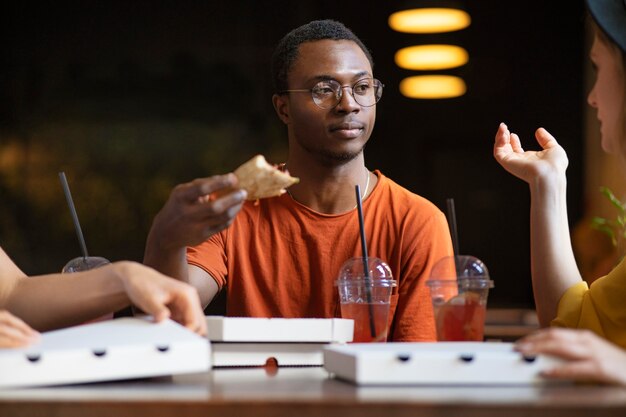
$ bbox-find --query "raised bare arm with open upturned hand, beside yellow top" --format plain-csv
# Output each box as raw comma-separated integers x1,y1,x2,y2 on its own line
494,123,582,326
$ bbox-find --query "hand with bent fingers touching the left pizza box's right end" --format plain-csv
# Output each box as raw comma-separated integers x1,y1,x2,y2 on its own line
113,262,206,335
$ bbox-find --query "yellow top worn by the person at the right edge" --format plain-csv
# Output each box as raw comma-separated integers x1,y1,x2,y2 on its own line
551,260,626,348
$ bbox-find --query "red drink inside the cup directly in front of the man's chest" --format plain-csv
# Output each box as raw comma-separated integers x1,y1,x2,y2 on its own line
341,303,389,343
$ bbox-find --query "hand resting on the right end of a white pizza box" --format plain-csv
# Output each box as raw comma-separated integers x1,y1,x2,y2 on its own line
516,328,626,385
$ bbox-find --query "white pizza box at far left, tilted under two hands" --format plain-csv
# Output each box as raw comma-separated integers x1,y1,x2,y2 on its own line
0,317,211,388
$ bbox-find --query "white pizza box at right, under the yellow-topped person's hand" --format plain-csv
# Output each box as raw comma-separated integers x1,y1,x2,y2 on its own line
324,342,561,385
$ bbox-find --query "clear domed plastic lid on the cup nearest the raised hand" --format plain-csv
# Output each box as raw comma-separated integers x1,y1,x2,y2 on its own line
429,255,493,288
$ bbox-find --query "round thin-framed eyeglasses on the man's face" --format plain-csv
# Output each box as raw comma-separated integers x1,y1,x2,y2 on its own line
278,78,385,109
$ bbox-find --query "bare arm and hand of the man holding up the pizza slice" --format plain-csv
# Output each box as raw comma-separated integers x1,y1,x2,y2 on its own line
144,174,246,305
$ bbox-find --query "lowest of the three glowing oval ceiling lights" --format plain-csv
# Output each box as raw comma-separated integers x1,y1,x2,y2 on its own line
400,75,467,99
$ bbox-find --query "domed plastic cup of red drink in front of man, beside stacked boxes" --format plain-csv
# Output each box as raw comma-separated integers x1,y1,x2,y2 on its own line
335,258,396,343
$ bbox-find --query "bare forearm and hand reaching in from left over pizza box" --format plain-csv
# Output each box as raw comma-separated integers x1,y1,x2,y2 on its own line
0,248,206,334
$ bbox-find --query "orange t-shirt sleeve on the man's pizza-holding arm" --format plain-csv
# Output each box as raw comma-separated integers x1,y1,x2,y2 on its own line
187,232,228,290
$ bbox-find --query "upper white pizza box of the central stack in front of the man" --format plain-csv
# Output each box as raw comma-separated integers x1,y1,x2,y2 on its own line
206,316,354,343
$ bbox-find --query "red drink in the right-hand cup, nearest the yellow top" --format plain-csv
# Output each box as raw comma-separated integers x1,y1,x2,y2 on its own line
435,292,486,342
